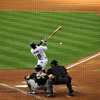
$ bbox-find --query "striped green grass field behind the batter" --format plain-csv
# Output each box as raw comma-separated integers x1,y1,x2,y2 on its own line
0,11,100,69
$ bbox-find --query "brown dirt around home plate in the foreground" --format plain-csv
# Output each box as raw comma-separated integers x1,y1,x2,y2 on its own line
0,52,100,100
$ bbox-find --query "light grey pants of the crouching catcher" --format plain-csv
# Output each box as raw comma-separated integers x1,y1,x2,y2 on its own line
27,79,46,90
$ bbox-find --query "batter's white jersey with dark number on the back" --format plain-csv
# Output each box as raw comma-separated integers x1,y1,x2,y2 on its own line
31,46,47,60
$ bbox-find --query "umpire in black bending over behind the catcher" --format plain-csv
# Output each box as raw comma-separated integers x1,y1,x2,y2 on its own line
46,60,74,97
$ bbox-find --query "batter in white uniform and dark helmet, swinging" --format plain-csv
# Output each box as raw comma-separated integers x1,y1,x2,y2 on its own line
30,40,48,70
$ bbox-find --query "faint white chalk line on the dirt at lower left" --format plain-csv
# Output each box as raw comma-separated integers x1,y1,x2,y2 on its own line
0,83,42,99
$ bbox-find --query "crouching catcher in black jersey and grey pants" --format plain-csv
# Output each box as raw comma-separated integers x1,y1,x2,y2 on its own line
24,65,49,94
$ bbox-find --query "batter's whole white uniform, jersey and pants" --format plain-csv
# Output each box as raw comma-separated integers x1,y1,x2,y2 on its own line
31,46,48,70
